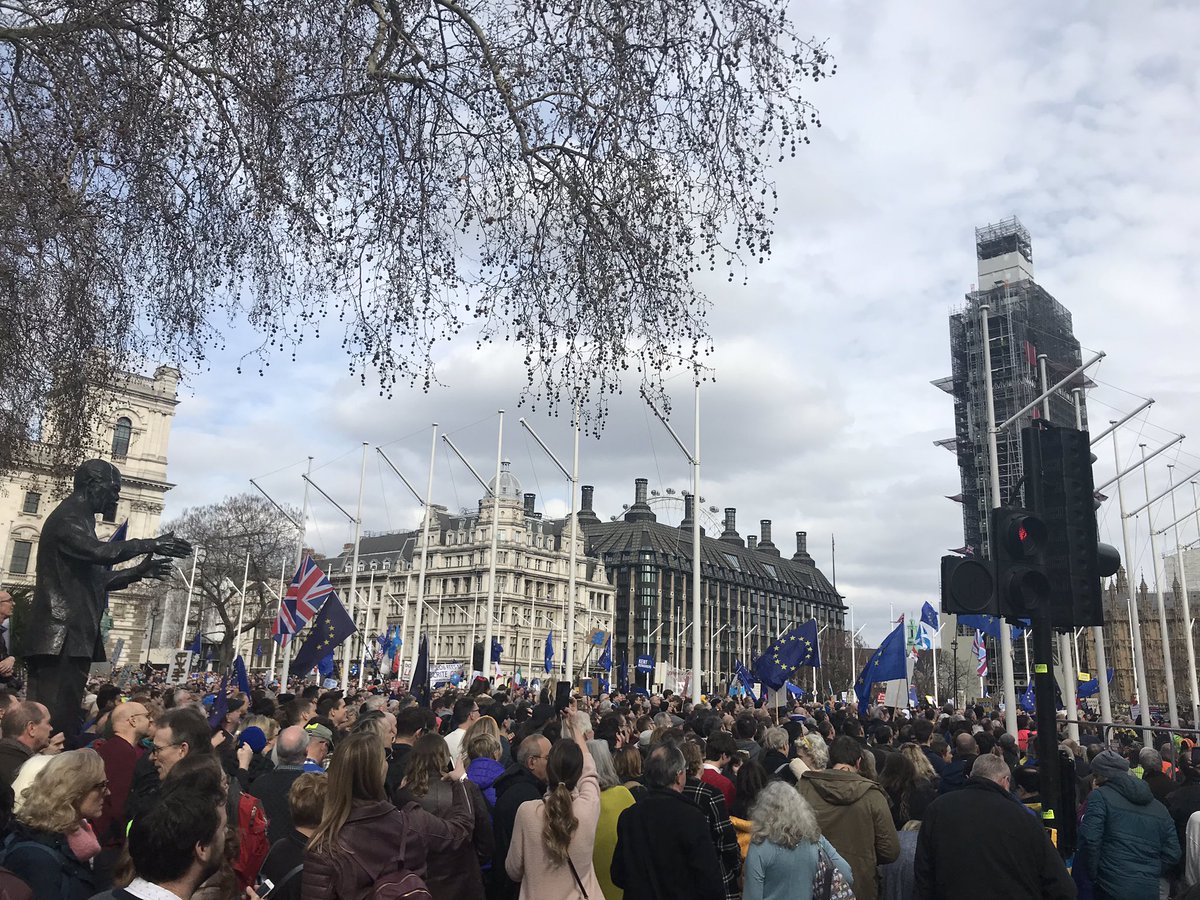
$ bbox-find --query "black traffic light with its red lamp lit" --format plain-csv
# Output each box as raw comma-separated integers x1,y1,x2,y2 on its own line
991,506,1050,619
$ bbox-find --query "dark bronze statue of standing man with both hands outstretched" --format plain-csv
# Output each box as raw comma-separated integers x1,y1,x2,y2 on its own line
20,460,192,748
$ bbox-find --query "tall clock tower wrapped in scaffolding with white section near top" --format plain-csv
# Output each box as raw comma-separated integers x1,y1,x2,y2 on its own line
934,216,1090,696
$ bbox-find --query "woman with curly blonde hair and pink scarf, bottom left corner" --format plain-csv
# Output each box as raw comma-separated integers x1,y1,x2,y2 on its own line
5,749,108,900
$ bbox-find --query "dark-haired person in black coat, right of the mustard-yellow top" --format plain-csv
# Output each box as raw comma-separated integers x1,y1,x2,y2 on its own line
610,744,725,900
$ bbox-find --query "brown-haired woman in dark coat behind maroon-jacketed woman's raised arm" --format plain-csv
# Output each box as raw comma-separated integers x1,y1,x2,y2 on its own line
392,734,496,900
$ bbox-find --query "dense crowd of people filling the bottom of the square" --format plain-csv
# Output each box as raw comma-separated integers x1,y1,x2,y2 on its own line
0,678,1200,900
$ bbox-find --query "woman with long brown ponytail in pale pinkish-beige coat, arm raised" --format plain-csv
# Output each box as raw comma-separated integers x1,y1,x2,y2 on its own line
504,718,604,900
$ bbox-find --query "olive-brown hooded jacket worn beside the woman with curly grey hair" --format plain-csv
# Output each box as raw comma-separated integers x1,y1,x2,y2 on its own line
797,769,900,900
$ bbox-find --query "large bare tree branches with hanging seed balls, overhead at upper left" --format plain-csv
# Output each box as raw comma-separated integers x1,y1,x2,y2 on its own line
0,0,834,463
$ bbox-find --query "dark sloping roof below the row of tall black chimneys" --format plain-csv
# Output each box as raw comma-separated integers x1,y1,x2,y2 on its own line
586,521,841,606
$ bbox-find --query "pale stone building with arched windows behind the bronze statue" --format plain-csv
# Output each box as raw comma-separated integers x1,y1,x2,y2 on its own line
0,366,179,664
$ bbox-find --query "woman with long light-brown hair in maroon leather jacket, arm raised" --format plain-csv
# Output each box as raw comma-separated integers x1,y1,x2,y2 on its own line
301,732,472,900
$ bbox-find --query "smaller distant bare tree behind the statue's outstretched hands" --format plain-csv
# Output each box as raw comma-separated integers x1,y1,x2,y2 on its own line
166,493,299,665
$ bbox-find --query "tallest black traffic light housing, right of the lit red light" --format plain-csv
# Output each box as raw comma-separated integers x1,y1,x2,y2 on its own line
1021,421,1121,630
